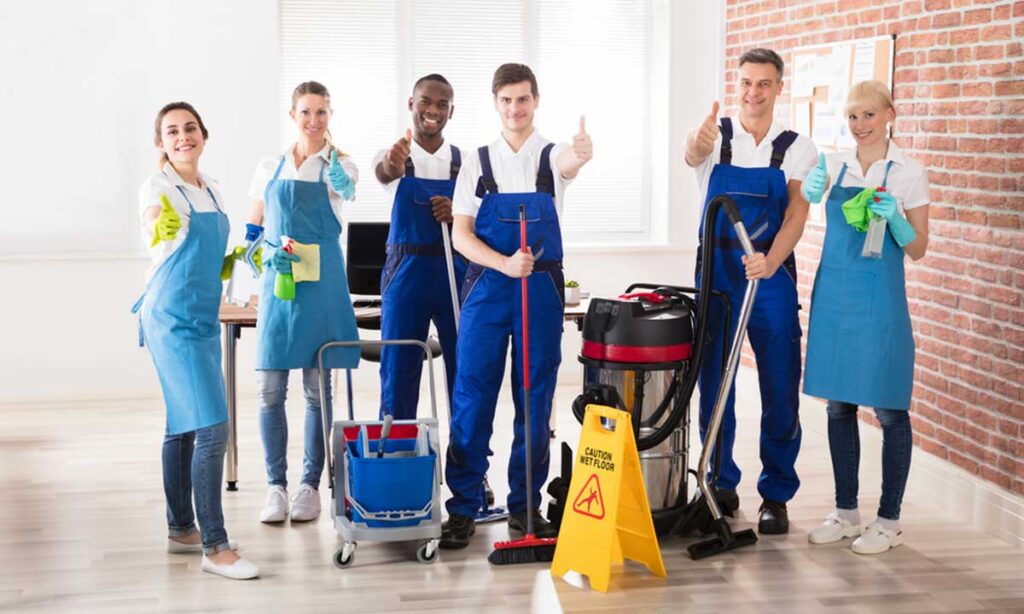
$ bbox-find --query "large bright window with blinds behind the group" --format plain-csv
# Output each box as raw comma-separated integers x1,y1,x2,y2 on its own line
281,0,652,243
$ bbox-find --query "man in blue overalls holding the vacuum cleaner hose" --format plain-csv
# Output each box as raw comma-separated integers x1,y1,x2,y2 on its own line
686,49,817,534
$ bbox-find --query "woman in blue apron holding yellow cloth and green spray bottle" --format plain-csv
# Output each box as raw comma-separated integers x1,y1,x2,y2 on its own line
249,81,359,523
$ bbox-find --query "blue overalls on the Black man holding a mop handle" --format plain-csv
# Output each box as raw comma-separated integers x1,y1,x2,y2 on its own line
381,147,466,420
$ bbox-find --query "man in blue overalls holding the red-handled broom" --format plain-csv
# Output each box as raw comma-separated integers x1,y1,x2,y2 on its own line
440,63,593,549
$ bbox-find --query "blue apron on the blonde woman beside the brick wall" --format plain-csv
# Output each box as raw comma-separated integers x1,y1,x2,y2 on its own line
804,161,914,409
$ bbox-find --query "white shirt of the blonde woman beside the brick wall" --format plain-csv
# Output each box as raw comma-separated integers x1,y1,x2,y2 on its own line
825,141,931,212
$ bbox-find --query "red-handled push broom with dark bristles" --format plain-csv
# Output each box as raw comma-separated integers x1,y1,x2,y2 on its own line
487,205,558,565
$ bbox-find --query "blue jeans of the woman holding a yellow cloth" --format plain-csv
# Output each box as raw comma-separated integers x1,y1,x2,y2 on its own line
258,368,331,488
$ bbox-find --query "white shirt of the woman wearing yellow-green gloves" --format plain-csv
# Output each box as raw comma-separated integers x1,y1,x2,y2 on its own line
138,162,224,281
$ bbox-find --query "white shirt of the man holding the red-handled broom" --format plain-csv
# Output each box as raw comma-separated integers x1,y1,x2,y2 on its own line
452,130,571,218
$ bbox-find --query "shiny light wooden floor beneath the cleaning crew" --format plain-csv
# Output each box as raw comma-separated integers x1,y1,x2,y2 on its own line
0,374,1024,613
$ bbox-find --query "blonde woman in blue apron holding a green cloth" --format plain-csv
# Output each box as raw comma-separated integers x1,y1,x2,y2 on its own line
803,81,929,555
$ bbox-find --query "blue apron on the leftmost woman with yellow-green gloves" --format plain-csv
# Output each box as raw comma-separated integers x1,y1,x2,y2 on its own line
132,186,228,435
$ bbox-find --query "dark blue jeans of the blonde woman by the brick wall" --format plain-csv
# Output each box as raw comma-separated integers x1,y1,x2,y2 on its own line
828,401,913,520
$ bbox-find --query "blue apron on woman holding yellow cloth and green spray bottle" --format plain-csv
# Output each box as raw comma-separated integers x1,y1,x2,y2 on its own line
256,156,359,370
